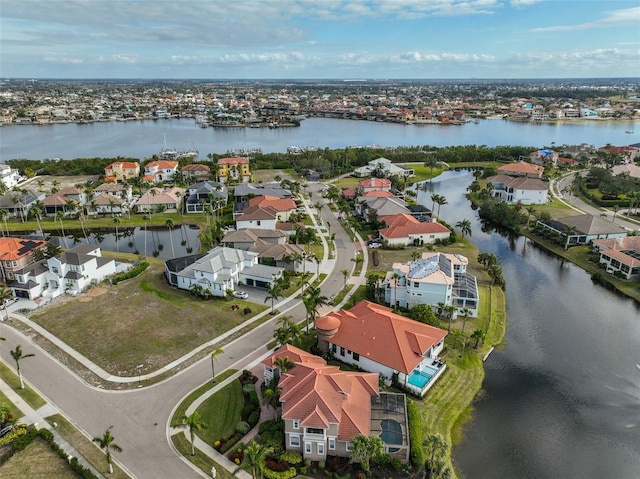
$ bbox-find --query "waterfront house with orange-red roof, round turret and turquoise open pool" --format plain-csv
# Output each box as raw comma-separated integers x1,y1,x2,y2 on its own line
315,300,447,396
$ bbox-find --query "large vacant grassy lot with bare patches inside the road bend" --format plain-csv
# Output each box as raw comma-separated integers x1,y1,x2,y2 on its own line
31,260,267,376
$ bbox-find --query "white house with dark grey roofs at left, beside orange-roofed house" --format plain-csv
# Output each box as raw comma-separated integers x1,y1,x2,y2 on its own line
10,245,116,299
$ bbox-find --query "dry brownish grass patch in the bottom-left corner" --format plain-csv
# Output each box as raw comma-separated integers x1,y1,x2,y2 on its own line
0,438,78,479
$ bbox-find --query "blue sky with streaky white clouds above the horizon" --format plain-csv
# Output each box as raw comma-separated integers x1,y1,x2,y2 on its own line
0,0,640,79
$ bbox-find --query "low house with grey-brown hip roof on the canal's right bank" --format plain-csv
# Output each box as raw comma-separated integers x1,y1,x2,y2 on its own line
536,215,627,246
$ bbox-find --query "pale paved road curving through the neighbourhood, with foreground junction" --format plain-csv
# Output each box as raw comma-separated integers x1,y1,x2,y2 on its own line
0,184,355,479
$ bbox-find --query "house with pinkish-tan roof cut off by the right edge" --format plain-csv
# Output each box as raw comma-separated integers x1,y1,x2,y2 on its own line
592,236,640,280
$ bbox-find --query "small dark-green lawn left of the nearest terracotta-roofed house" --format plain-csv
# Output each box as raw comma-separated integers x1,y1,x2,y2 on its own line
197,380,244,446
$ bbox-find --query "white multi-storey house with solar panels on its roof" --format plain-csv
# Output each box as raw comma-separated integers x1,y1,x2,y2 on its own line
383,252,480,317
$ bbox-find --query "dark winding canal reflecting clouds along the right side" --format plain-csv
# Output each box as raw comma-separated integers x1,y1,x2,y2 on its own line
418,171,640,479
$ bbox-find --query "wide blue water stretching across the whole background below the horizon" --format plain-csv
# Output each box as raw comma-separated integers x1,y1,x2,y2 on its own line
0,118,640,161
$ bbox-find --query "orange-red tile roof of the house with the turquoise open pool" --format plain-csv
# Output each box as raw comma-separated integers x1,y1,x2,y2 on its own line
318,300,447,374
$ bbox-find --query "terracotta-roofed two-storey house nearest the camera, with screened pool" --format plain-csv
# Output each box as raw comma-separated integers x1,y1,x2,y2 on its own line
262,345,409,463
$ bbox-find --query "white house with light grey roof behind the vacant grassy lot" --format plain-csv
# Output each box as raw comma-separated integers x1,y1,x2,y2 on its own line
165,246,283,297
